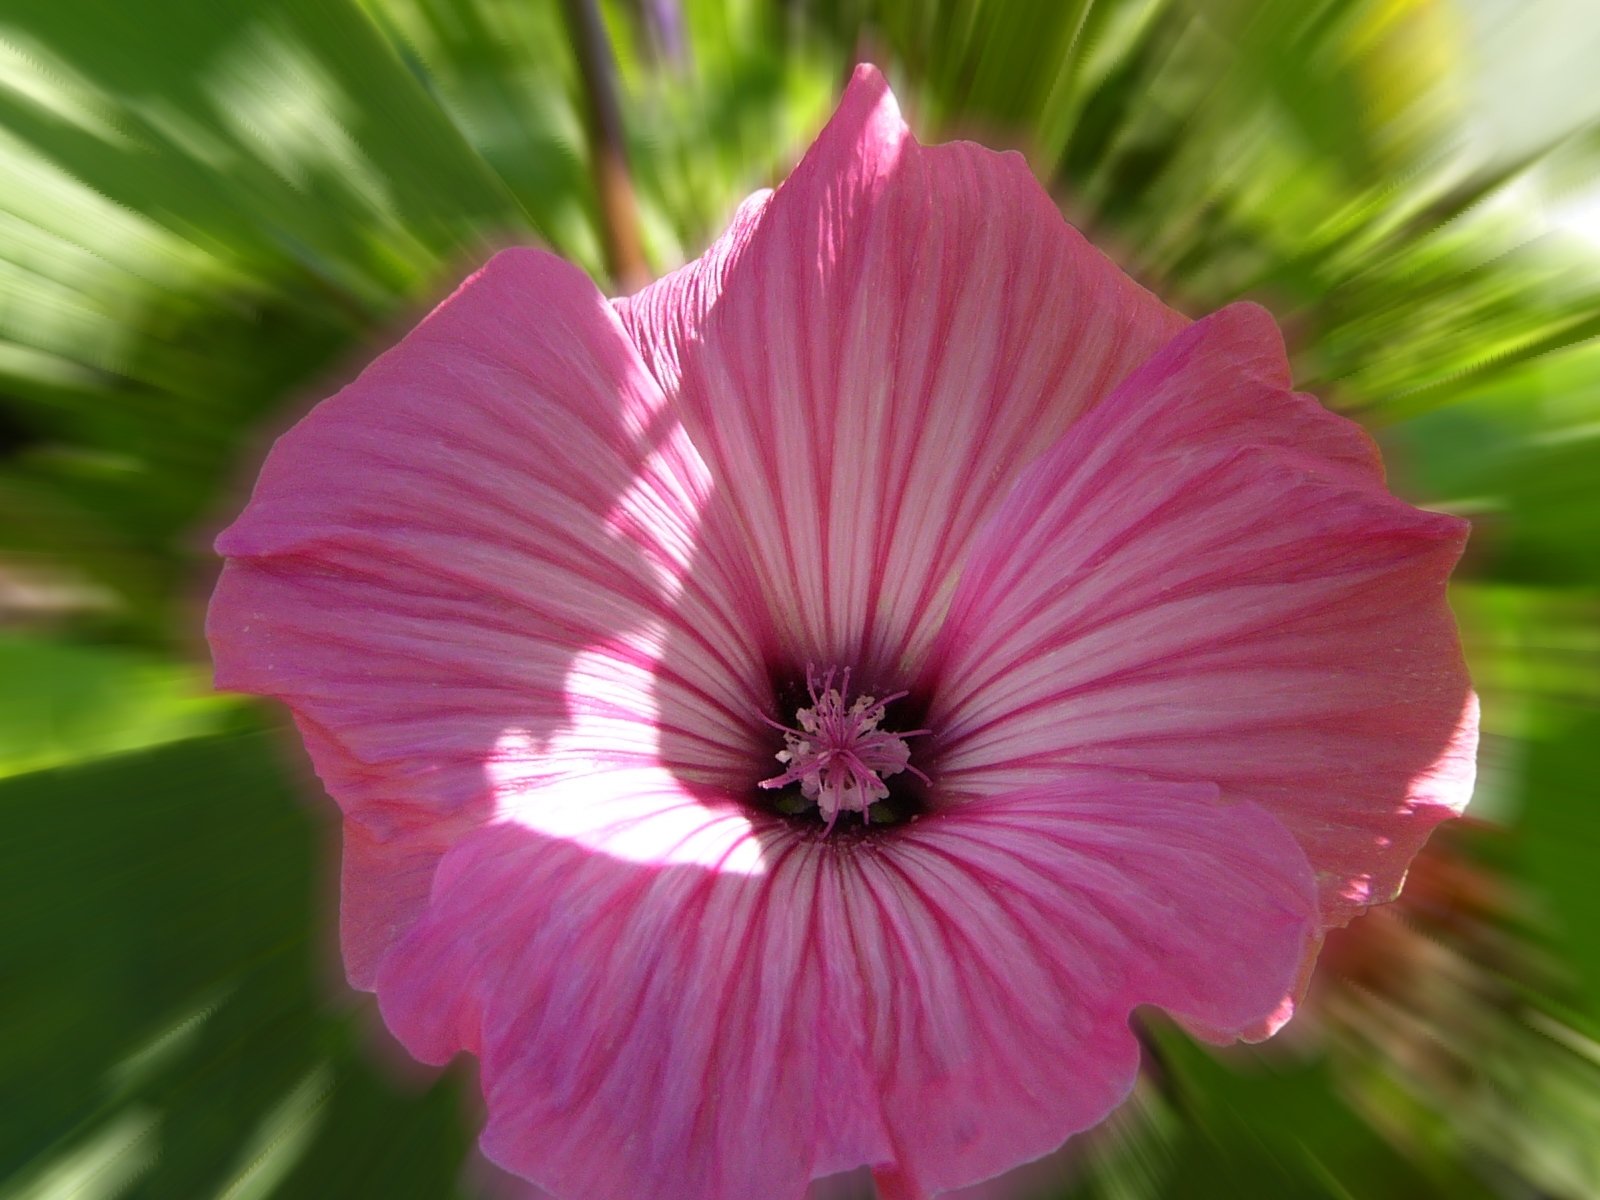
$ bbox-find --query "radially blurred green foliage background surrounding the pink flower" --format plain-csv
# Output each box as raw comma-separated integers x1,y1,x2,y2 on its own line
0,0,1600,1200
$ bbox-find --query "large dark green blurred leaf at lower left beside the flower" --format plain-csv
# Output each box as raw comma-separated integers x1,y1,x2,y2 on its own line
0,733,470,1200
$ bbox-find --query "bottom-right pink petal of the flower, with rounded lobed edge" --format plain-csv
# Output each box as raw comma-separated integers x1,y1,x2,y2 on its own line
853,774,1317,1195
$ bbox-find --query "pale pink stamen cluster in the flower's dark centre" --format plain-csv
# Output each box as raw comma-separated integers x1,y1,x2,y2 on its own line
760,667,928,832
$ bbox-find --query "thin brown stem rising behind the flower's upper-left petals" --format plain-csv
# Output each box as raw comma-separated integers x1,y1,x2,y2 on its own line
562,0,650,291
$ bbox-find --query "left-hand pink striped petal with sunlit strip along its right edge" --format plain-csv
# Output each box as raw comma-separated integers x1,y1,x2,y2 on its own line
208,251,765,979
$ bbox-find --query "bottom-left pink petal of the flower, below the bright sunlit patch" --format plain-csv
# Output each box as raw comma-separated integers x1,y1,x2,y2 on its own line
378,809,886,1200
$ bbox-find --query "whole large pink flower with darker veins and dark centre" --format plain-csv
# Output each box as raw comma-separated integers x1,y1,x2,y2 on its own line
210,67,1475,1200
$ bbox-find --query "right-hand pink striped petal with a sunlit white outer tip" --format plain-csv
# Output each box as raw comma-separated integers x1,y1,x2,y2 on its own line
928,307,1477,925
